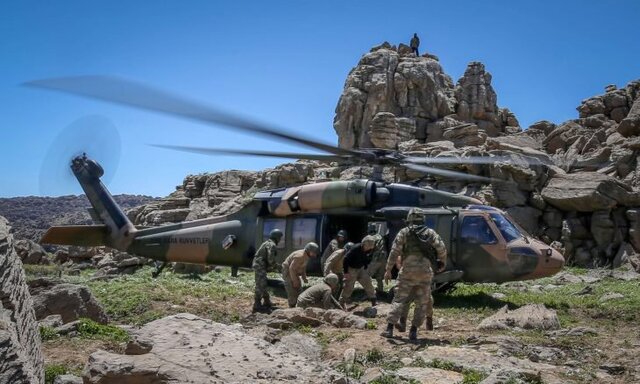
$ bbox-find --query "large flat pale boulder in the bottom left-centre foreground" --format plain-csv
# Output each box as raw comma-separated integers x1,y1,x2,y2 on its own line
84,313,341,384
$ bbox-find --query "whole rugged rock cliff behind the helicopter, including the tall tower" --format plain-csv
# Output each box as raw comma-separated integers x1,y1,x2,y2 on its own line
130,43,640,266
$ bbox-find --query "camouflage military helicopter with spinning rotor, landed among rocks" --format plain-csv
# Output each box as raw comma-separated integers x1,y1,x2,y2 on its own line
27,76,564,285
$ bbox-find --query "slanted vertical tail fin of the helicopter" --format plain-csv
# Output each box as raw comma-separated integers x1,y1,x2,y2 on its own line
71,154,136,251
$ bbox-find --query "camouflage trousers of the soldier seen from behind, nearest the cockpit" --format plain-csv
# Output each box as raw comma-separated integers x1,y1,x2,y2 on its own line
387,278,433,328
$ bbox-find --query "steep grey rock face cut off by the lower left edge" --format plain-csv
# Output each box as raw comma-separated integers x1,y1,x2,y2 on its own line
0,216,44,384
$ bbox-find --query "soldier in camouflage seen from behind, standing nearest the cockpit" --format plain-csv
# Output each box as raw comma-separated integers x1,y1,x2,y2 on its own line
382,208,447,340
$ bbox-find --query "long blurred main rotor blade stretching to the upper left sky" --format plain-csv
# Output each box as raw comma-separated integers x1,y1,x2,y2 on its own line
25,76,354,155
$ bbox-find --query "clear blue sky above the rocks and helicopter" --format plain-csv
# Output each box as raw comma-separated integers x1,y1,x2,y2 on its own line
0,0,640,196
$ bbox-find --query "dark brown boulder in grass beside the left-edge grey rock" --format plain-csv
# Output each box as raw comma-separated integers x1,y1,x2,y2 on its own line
31,282,108,323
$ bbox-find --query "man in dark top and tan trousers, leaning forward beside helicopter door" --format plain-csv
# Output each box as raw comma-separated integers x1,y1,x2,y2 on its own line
340,236,376,307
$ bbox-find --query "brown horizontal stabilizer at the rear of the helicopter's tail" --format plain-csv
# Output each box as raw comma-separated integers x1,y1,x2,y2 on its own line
40,225,109,247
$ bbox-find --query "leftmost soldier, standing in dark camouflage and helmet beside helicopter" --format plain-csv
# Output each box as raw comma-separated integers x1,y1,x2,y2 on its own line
252,228,283,312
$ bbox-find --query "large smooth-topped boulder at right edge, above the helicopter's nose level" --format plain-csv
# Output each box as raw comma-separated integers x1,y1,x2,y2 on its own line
542,172,640,212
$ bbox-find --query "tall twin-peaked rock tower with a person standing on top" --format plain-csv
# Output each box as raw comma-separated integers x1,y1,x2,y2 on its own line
333,43,520,149
